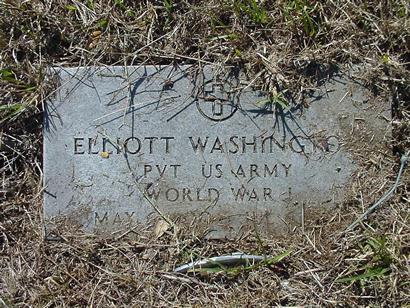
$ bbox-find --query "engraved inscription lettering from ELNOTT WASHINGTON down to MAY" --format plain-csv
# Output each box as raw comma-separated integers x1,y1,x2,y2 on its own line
73,131,337,224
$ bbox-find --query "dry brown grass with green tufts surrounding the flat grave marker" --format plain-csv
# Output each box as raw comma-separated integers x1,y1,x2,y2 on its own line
0,0,410,307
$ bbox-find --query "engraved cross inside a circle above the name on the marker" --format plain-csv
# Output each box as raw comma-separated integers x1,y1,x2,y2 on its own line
196,81,239,122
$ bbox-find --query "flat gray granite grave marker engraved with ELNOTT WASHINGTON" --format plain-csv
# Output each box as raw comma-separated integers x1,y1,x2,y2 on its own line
44,66,389,237
